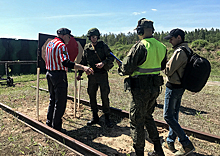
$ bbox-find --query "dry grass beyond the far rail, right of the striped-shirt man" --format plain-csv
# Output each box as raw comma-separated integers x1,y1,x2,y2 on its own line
69,72,220,136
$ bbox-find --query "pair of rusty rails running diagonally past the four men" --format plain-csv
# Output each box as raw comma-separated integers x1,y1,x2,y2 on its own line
0,86,220,156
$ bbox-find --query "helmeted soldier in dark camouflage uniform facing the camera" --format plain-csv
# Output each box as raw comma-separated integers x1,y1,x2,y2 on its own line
77,28,114,127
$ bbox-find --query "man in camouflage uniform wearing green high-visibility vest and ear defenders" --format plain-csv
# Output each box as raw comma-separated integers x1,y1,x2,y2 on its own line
117,18,167,156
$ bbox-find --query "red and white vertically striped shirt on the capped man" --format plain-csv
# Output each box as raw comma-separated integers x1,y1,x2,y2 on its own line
45,37,69,71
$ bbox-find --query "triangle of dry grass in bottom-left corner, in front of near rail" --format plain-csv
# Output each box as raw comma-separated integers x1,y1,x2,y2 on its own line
0,109,74,156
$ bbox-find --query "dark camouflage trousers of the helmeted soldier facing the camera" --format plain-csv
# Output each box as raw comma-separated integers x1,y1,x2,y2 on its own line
87,72,110,114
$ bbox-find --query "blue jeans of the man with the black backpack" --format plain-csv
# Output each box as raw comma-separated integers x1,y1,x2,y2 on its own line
163,87,190,146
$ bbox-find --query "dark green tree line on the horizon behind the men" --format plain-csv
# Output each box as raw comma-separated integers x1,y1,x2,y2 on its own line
80,28,220,46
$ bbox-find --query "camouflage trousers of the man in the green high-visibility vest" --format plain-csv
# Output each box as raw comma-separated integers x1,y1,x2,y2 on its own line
130,86,159,150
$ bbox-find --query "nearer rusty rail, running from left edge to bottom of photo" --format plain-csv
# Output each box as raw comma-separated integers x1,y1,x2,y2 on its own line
0,103,107,156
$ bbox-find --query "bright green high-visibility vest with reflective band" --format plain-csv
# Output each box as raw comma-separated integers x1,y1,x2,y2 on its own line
131,38,166,77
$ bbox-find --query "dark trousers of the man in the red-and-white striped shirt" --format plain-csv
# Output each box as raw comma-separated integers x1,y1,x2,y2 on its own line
46,70,68,130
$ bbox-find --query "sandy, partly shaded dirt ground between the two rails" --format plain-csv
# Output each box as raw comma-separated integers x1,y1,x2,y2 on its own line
14,93,218,156
